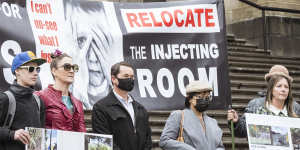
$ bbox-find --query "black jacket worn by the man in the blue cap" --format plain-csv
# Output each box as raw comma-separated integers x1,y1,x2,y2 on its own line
0,82,45,150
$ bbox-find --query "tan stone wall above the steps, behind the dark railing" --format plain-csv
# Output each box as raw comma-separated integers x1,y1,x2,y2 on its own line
94,0,300,57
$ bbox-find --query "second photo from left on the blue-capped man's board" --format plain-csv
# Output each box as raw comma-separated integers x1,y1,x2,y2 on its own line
45,129,57,150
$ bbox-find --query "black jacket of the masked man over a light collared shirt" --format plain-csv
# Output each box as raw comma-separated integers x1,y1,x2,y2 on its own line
92,91,152,150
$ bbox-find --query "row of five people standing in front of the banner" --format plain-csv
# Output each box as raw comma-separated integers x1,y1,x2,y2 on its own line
0,50,300,150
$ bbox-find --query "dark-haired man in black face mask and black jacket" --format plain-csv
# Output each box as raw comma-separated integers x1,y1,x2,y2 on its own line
92,62,152,150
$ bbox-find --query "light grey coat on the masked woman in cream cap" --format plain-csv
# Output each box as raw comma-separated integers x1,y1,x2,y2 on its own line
159,109,224,150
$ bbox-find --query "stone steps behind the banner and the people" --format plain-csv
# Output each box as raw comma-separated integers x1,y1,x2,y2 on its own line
85,34,300,150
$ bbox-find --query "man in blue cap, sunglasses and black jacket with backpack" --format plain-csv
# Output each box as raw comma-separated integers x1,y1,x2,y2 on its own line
0,51,46,150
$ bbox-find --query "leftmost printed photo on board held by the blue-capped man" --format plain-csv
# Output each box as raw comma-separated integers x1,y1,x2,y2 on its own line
27,128,43,150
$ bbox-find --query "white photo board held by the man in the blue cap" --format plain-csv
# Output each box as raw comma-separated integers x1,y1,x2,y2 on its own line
26,128,113,150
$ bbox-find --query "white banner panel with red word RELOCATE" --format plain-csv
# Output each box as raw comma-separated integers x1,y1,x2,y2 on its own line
121,4,220,33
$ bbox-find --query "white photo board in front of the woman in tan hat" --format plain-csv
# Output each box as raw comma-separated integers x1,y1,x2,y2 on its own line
245,113,300,150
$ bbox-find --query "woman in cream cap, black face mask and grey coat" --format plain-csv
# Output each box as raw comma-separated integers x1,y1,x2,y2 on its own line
159,81,224,150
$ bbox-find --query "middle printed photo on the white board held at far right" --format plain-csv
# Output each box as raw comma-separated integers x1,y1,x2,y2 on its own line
271,126,290,147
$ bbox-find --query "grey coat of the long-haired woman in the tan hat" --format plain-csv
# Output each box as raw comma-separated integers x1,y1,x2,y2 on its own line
233,97,300,137
